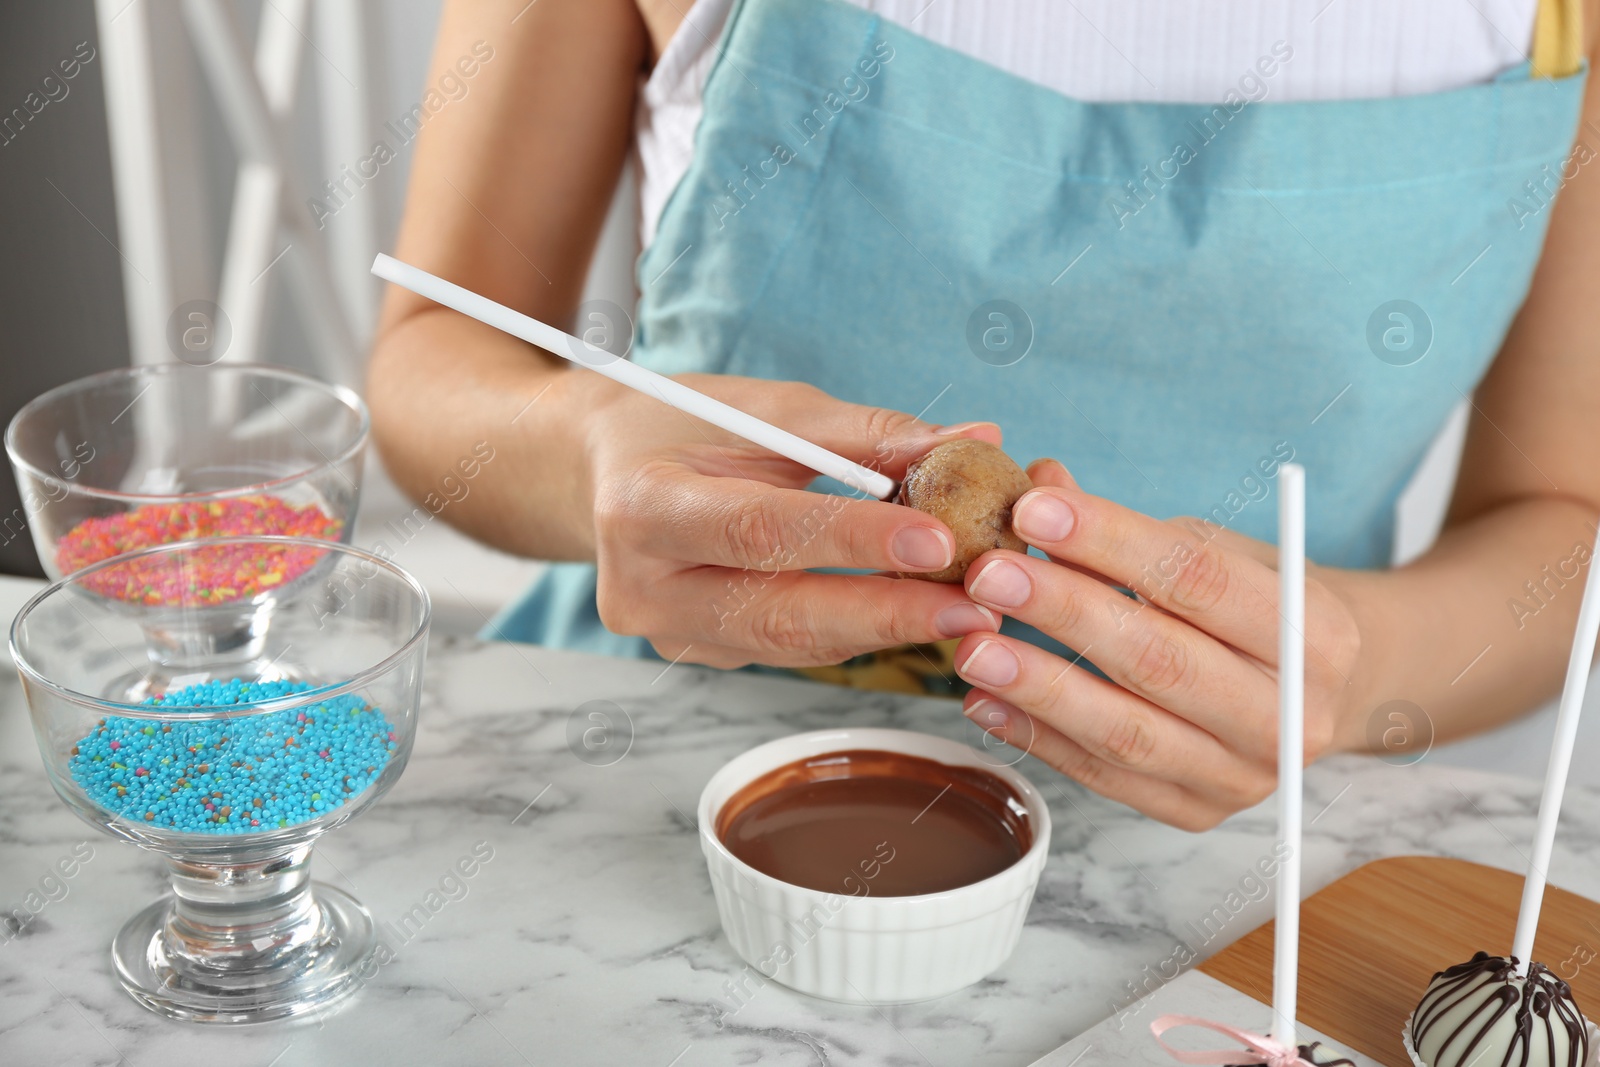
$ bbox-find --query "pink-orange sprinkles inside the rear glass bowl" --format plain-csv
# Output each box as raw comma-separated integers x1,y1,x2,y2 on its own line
56,496,344,606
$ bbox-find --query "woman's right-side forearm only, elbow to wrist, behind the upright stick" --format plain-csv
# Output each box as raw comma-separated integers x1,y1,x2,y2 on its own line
1309,496,1600,750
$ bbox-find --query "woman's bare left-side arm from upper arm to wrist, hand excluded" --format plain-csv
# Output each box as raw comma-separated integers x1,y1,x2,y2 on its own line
366,0,646,560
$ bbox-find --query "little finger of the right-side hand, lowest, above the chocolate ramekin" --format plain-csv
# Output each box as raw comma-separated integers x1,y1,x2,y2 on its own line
962,689,1227,830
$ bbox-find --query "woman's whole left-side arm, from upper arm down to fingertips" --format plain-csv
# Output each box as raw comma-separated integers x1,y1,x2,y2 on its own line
368,0,998,667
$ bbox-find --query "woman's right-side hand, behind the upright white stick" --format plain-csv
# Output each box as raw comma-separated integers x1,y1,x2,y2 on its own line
955,461,1362,830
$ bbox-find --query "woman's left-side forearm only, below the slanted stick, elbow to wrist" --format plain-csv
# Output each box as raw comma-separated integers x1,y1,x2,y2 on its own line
368,309,614,560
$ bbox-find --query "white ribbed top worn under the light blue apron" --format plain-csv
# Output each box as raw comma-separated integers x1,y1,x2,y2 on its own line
635,0,1538,245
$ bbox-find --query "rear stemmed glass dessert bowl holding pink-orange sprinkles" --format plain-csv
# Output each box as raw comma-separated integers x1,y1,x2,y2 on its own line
5,363,370,701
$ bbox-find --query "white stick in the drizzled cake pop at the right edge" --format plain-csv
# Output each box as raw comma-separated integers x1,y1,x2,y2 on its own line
1510,521,1600,976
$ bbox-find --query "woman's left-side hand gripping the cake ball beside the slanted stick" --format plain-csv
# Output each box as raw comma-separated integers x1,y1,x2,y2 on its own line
573,374,1000,667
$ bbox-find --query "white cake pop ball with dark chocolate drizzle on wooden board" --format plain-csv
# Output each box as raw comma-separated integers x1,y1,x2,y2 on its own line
1411,952,1589,1067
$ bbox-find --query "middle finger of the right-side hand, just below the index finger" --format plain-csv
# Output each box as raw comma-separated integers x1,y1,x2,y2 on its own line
966,550,1277,758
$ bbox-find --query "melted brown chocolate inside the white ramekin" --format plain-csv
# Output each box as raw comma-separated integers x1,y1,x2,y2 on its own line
717,750,1034,896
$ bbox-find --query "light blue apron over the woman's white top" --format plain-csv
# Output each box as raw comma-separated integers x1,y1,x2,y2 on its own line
486,0,1584,671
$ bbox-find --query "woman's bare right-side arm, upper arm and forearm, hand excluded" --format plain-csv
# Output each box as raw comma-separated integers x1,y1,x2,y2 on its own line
1333,18,1600,749
